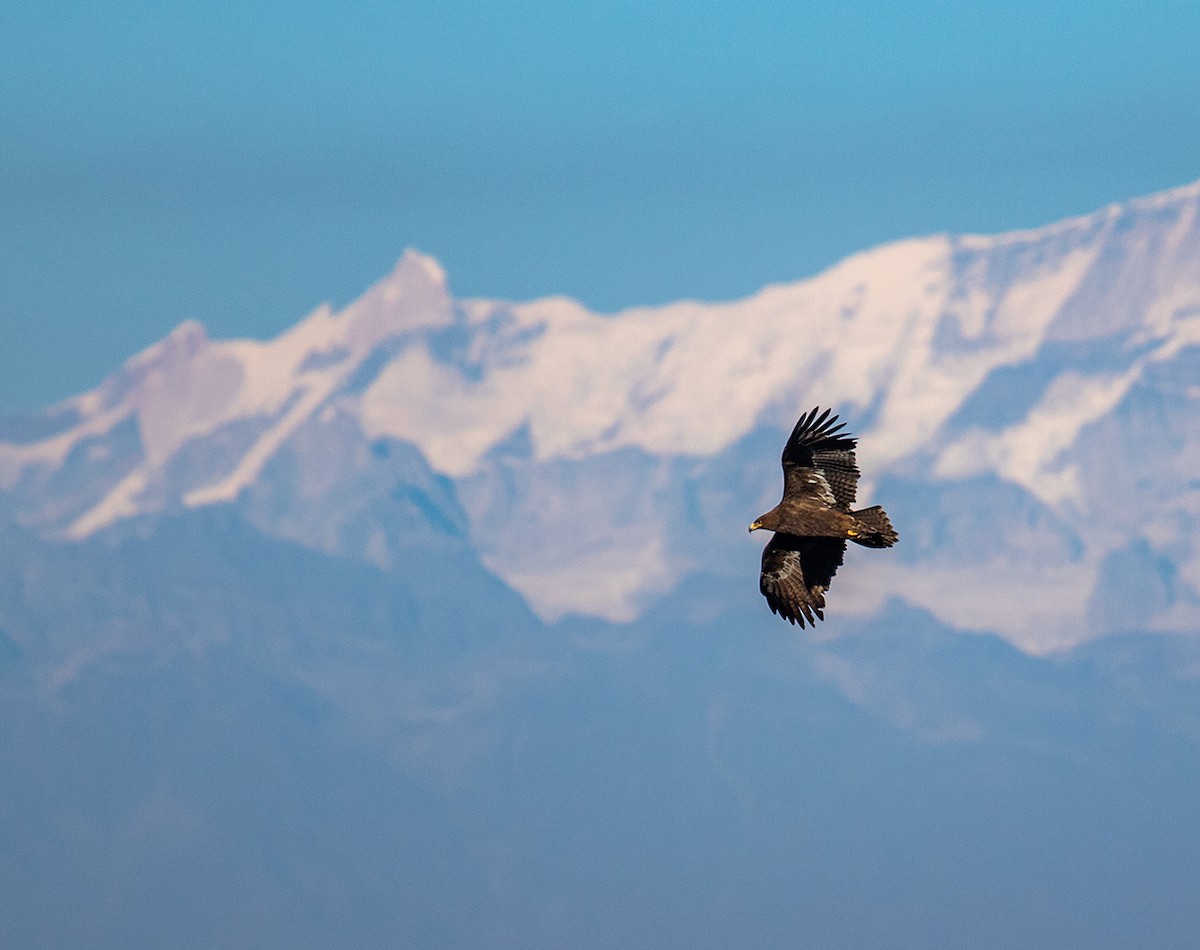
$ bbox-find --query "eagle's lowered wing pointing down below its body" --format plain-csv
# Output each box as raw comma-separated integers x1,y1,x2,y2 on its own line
758,534,846,627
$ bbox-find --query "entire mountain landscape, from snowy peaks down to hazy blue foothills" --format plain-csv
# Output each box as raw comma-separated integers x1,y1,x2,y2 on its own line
0,179,1200,950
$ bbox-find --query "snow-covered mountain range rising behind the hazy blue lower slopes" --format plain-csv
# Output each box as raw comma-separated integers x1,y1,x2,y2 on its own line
0,182,1200,651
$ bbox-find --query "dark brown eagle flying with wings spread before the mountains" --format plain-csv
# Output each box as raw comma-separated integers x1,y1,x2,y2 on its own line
750,407,900,627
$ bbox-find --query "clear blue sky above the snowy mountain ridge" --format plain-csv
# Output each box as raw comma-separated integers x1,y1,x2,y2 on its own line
0,0,1200,409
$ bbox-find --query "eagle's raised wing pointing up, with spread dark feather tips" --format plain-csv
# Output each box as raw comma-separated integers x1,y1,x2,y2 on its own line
782,408,858,511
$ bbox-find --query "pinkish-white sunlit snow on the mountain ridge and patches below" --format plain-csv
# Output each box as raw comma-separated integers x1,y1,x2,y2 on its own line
7,182,1200,650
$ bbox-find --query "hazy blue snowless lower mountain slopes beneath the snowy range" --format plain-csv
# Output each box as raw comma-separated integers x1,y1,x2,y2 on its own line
0,520,1200,950
